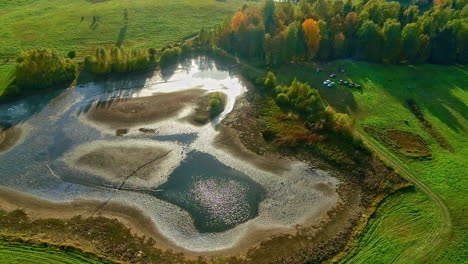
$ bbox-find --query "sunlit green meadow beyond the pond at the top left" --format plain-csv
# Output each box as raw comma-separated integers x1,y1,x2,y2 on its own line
0,0,244,59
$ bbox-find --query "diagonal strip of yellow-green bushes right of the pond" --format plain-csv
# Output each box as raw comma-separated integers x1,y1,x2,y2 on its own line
264,72,354,144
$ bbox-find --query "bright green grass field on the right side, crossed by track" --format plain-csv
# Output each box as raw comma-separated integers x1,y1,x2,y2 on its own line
266,61,468,264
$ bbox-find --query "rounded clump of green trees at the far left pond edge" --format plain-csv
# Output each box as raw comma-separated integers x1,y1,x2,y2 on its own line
4,48,78,96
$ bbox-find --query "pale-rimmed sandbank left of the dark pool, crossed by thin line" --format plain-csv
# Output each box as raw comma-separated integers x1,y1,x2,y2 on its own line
64,140,183,189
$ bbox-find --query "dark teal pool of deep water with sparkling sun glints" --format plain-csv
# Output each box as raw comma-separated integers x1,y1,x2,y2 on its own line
150,151,266,233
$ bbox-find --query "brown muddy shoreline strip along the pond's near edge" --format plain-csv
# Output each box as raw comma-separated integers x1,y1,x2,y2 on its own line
0,184,359,259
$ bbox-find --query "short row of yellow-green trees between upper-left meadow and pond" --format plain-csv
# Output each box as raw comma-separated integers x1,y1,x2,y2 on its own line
84,47,157,74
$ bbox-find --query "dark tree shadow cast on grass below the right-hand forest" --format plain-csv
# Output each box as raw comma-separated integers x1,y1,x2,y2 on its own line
349,62,468,133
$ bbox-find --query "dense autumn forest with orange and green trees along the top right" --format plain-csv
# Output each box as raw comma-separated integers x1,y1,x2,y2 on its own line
197,0,468,65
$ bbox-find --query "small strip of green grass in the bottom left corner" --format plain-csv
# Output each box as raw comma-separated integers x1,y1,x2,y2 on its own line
0,240,111,264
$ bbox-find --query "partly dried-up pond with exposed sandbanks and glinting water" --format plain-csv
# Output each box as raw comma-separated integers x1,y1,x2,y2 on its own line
0,57,339,252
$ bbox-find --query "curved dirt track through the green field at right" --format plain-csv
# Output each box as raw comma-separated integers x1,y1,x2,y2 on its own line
355,129,452,263
